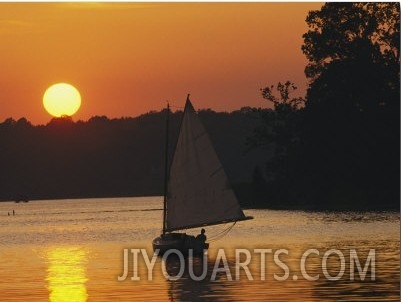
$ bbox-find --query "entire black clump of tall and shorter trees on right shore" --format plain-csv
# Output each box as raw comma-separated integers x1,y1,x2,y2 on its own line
250,2,400,209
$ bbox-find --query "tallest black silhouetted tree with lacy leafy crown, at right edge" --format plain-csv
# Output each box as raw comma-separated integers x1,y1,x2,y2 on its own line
300,2,400,209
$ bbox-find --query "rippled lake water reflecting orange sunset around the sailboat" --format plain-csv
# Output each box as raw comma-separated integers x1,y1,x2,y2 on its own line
0,197,400,302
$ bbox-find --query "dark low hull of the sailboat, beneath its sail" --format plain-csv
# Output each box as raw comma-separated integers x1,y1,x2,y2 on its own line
152,233,209,256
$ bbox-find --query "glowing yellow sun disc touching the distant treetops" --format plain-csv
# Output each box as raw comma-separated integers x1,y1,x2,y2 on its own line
43,83,81,117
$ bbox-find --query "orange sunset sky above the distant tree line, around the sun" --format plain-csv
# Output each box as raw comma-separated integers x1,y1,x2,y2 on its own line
0,2,322,124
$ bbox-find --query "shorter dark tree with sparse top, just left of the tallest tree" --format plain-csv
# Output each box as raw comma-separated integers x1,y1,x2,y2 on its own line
247,81,305,207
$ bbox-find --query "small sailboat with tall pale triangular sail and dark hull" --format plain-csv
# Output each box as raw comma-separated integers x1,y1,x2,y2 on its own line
152,95,253,255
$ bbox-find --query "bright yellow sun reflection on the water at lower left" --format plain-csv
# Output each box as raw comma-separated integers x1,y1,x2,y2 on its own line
46,247,88,302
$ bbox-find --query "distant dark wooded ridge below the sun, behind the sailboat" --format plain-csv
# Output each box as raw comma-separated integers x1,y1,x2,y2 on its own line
0,108,266,204
